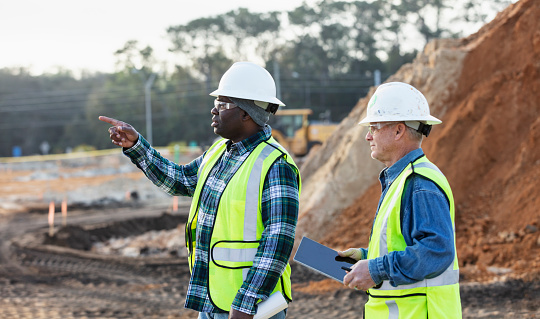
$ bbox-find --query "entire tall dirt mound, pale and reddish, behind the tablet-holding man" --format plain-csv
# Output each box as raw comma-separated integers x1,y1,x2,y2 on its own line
298,0,540,280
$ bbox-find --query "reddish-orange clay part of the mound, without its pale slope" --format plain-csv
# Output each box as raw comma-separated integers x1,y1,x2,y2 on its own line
323,0,540,281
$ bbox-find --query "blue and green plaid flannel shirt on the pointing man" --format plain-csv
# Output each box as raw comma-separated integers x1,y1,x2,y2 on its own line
124,125,299,314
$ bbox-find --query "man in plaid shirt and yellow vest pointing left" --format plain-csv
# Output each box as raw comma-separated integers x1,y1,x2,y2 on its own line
100,62,300,319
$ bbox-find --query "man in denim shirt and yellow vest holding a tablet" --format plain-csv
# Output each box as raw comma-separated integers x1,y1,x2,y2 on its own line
339,82,461,319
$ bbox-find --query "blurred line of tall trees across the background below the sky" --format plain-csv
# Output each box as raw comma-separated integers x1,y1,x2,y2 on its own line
0,0,509,157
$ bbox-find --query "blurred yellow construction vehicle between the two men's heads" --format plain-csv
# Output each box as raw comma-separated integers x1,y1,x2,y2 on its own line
269,109,337,156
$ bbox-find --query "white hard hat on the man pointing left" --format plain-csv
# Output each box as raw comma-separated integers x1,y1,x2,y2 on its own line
210,62,285,108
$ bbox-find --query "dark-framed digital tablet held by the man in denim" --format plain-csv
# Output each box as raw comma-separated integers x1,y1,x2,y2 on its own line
293,237,356,283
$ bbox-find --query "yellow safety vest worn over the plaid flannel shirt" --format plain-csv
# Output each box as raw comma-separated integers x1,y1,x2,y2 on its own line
186,138,300,312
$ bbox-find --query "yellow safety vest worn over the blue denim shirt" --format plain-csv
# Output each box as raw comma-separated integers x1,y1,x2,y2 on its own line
365,156,462,319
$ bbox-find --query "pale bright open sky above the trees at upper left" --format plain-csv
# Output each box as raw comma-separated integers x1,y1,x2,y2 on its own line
0,0,309,75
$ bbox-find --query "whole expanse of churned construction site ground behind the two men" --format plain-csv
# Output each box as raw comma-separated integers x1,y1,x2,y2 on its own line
0,156,540,319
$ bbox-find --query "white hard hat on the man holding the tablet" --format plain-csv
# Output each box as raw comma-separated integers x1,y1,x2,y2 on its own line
358,82,442,126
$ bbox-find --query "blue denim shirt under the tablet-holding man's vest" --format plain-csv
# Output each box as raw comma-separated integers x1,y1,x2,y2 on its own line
362,148,455,287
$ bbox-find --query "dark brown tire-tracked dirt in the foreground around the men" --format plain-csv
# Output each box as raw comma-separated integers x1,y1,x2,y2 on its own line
0,206,540,319
